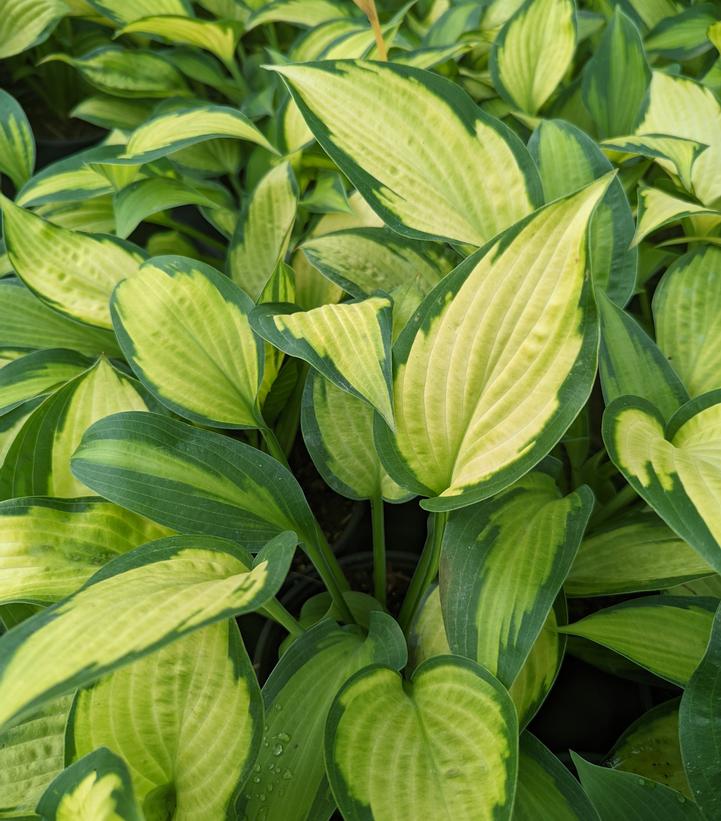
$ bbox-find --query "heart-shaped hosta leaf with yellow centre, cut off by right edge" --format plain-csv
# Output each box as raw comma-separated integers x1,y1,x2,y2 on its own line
603,392,721,572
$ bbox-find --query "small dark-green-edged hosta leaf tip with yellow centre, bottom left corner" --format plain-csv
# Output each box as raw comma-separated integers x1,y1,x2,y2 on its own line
37,747,144,821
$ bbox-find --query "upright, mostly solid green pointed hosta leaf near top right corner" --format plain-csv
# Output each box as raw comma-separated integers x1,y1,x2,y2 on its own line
582,6,651,139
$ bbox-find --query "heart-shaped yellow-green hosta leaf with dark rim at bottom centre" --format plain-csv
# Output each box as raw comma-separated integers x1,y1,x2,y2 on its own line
326,656,518,821
